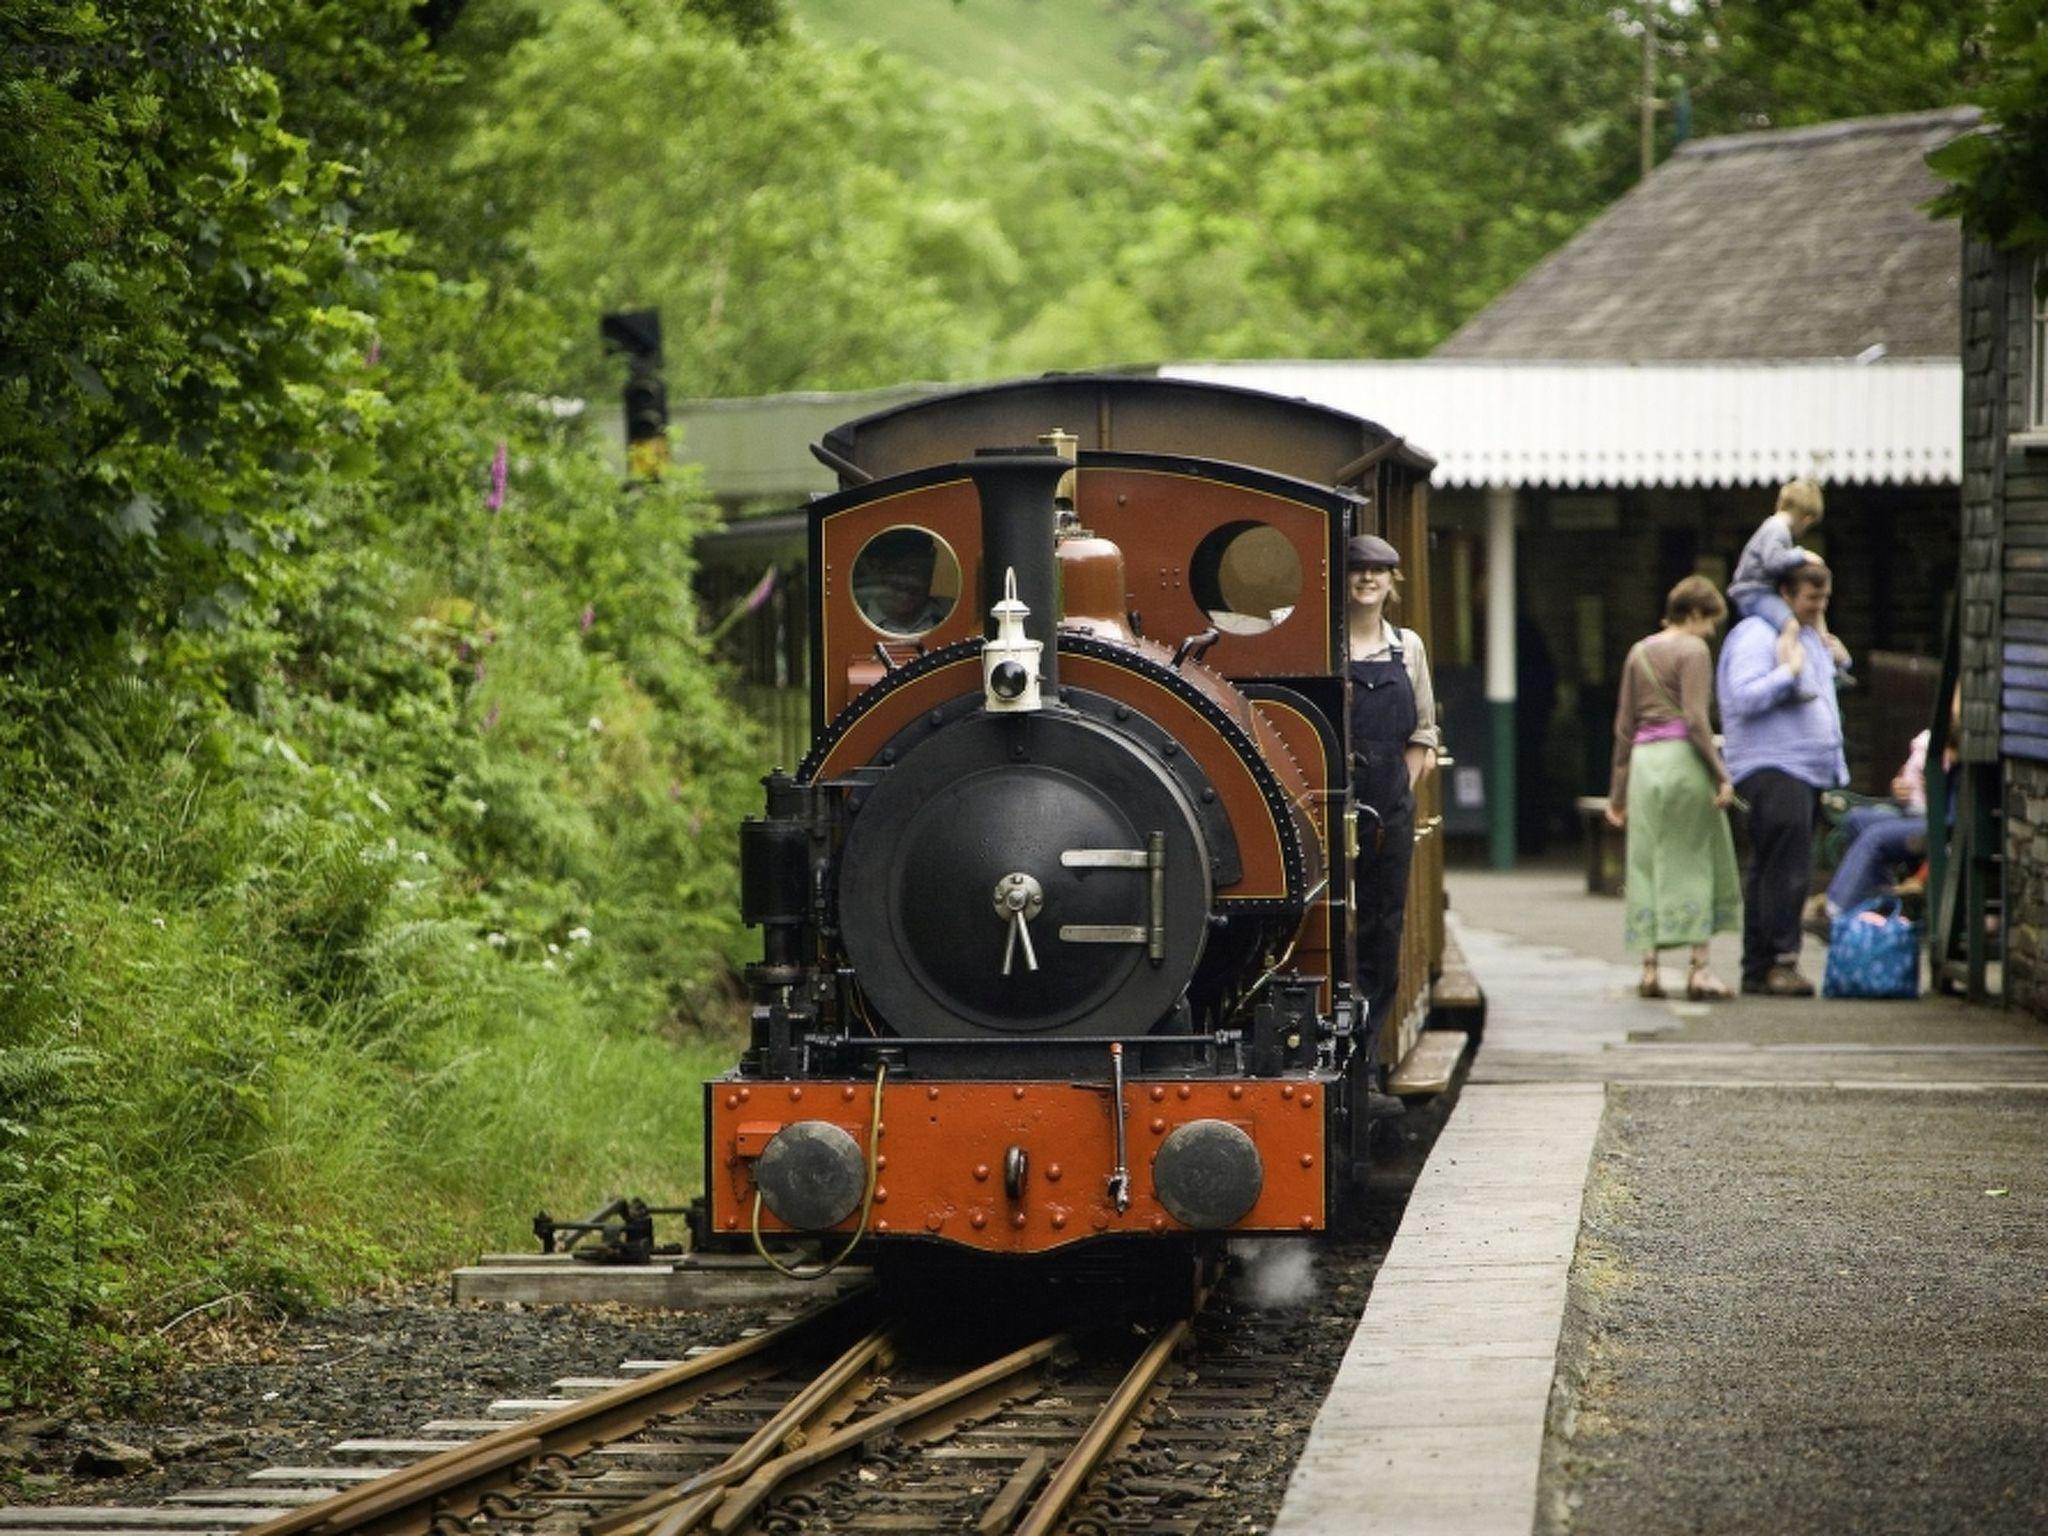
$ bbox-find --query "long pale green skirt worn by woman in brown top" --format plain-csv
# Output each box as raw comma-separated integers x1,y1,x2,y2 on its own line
1622,739,1743,954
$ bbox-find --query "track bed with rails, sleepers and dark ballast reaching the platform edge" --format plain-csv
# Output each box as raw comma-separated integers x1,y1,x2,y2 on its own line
0,1110,1440,1536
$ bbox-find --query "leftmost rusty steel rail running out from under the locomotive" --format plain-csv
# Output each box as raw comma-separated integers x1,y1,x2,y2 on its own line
242,1286,872,1536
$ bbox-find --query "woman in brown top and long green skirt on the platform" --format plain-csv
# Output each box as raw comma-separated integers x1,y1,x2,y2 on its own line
1608,575,1743,1001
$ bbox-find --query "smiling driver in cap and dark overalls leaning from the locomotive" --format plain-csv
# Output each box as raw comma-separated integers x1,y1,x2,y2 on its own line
1343,532,1442,1108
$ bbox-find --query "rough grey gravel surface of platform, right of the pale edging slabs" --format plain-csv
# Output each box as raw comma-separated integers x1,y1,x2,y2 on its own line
1538,1085,2048,1536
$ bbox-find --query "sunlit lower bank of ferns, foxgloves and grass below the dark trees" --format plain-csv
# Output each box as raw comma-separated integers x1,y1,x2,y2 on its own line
0,483,752,1397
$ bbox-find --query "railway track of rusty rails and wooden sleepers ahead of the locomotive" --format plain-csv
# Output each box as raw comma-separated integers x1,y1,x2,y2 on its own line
0,1292,1286,1536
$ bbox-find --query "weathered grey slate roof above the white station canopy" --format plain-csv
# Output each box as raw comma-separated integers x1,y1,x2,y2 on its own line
1434,106,1978,362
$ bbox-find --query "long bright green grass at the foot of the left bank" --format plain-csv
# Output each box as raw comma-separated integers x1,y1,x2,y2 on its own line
0,741,739,1403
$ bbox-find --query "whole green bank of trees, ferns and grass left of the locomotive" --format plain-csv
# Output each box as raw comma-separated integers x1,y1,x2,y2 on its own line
0,0,772,1401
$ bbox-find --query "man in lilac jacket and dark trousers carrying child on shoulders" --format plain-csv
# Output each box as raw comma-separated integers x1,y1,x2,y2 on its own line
1718,561,1849,997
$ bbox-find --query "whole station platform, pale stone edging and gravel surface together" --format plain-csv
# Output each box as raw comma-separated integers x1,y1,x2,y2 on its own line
1272,864,2048,1536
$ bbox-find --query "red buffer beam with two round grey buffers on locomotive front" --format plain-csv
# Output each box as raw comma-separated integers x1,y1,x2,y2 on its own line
705,1075,1333,1253
